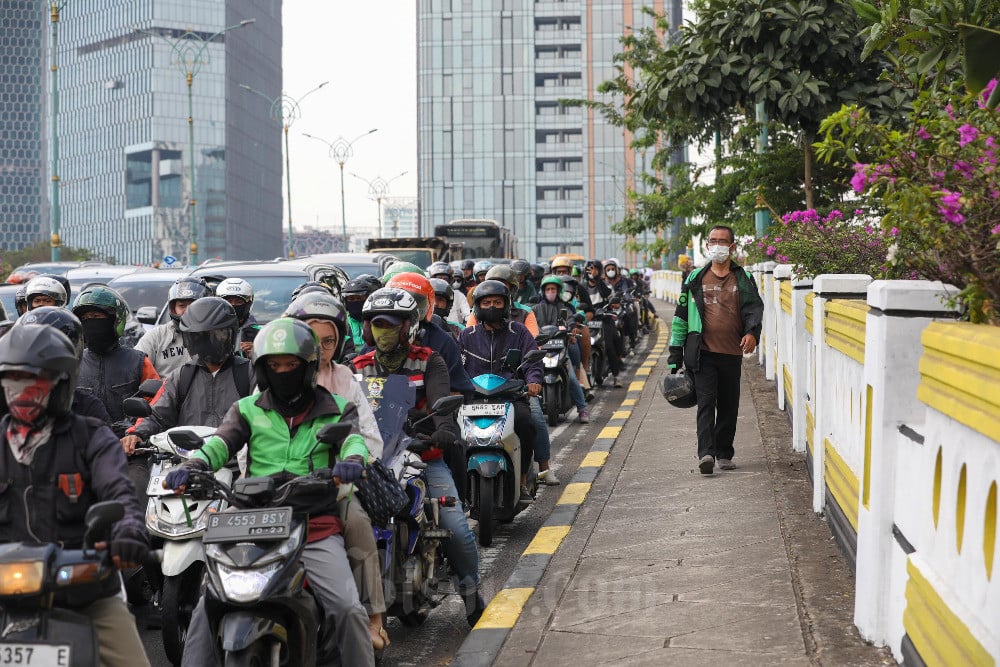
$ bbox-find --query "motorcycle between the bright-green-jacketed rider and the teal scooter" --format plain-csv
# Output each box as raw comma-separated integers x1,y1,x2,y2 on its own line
361,375,463,627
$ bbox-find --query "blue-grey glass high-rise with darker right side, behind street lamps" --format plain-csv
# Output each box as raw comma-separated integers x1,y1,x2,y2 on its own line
58,0,282,263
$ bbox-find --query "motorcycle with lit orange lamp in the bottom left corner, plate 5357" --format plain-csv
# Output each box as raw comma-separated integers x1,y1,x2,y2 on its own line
0,501,125,667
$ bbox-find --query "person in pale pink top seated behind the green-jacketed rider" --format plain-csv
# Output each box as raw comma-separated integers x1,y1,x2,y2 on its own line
282,294,389,651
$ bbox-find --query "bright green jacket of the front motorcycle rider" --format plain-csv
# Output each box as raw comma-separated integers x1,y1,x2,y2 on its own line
194,387,368,477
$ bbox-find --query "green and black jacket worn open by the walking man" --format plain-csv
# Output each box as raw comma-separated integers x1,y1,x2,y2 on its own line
670,264,764,371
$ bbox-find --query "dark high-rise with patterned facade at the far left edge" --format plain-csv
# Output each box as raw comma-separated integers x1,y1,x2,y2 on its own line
0,0,49,250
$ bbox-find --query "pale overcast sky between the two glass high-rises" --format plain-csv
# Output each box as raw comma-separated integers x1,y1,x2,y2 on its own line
282,0,417,233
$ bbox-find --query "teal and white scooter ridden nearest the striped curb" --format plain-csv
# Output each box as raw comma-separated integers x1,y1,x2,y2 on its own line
458,350,546,547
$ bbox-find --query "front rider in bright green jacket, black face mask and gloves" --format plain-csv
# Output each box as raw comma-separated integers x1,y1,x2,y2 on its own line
165,318,375,666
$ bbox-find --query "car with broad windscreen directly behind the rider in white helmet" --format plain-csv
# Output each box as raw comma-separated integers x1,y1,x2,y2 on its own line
176,257,349,324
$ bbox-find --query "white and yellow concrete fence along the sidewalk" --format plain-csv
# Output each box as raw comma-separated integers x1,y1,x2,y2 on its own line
652,264,1000,665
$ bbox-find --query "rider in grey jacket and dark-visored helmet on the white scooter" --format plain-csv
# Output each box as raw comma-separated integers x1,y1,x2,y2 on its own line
122,296,257,455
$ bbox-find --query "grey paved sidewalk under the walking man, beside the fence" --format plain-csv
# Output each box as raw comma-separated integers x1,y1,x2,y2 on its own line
453,314,892,667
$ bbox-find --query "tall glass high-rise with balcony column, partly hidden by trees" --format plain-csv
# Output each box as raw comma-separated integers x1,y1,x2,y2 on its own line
417,0,664,261
